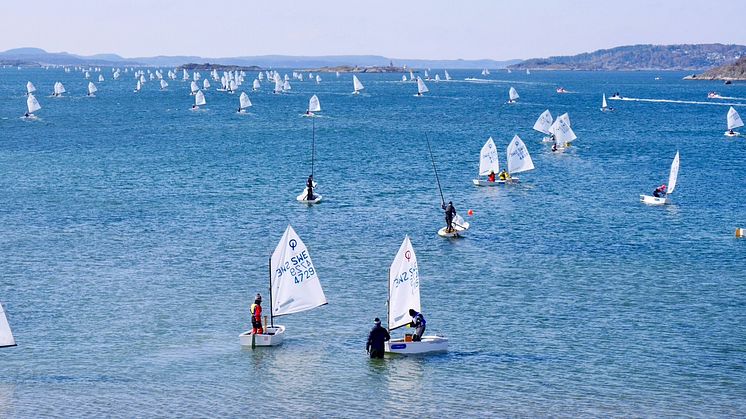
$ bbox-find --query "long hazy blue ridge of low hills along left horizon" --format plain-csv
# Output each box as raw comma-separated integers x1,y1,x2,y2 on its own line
0,48,520,69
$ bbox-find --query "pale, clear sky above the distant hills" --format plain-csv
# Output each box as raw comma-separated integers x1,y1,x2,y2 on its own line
0,0,746,60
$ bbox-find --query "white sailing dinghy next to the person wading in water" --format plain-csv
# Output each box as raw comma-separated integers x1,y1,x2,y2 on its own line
384,236,448,355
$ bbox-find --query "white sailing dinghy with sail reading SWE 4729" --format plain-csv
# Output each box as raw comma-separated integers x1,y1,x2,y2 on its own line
239,225,327,348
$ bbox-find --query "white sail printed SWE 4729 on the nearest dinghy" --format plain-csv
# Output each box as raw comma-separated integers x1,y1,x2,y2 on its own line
270,225,327,316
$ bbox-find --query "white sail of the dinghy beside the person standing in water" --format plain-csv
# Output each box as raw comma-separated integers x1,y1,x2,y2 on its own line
388,236,421,330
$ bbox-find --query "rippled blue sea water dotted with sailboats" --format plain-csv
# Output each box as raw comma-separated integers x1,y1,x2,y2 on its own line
0,69,746,417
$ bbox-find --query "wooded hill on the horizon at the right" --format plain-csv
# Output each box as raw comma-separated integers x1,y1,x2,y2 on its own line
509,44,746,71
